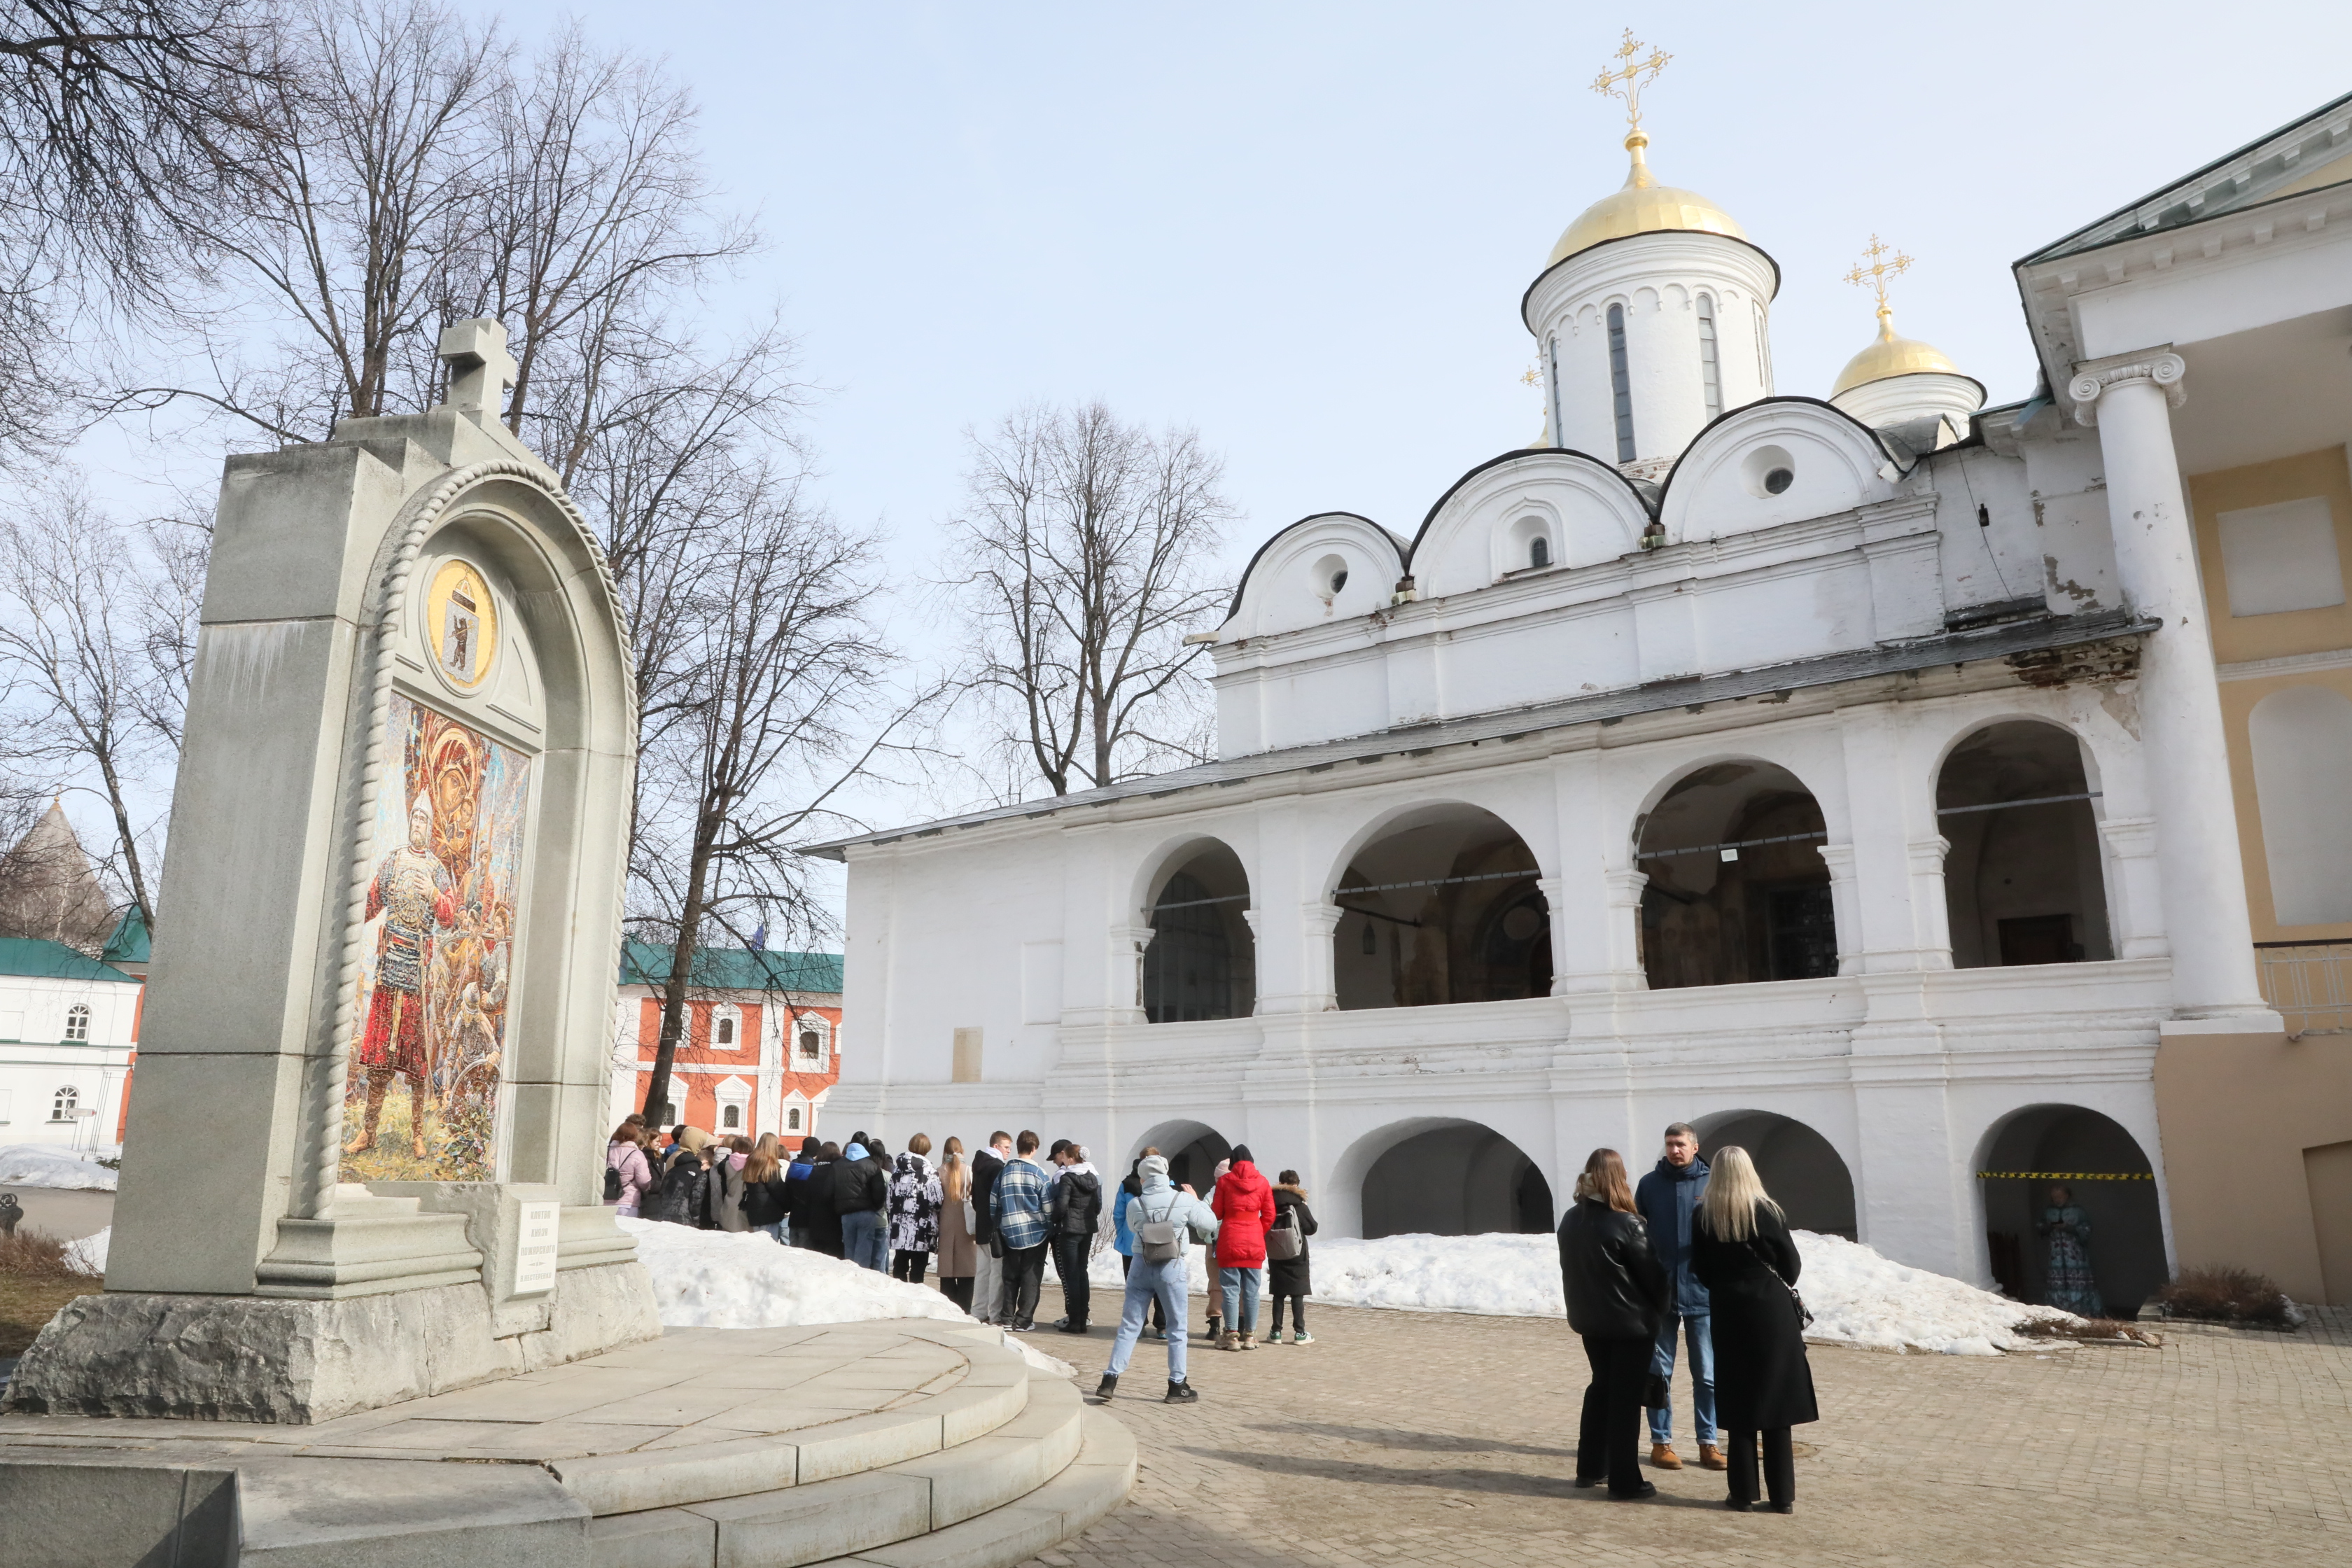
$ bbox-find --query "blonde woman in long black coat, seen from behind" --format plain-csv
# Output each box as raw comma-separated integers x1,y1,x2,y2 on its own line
1691,1145,1821,1514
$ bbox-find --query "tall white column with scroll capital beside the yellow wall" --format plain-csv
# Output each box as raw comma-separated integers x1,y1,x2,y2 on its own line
2067,350,2276,1028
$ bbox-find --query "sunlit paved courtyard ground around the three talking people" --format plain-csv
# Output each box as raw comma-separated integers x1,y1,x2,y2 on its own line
1032,1298,2352,1568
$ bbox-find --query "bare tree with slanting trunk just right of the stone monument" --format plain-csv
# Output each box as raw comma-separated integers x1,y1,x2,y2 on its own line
630,468,908,1116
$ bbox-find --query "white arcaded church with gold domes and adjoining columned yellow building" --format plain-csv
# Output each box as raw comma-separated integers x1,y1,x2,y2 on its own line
814,85,2352,1312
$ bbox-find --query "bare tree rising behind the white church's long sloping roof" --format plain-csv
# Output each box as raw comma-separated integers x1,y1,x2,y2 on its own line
946,402,1233,794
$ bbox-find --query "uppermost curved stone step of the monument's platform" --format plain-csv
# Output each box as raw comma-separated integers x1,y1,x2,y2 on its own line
548,1338,1030,1518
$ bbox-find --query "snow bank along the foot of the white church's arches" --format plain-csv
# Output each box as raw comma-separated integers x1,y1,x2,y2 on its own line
1058,1229,2079,1357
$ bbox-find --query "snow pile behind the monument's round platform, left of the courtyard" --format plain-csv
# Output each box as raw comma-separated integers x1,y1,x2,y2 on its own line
616,1218,1072,1378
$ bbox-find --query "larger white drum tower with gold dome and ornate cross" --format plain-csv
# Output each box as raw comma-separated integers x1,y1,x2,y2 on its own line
1522,31,1781,479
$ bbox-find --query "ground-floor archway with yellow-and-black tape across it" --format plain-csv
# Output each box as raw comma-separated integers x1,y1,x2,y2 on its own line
1975,1105,2171,1317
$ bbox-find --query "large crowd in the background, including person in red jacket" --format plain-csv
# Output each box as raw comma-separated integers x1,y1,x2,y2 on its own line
605,1116,1315,1404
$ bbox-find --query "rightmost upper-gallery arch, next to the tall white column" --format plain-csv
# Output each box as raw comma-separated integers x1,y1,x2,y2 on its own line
1935,720,2115,969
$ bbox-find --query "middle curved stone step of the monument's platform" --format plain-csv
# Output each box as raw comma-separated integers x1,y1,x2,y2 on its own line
588,1373,1091,1568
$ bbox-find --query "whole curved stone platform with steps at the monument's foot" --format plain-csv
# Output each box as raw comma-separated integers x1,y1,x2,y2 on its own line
0,1319,1136,1568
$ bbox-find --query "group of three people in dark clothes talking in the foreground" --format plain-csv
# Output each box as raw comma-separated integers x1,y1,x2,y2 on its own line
1560,1121,1821,1514
